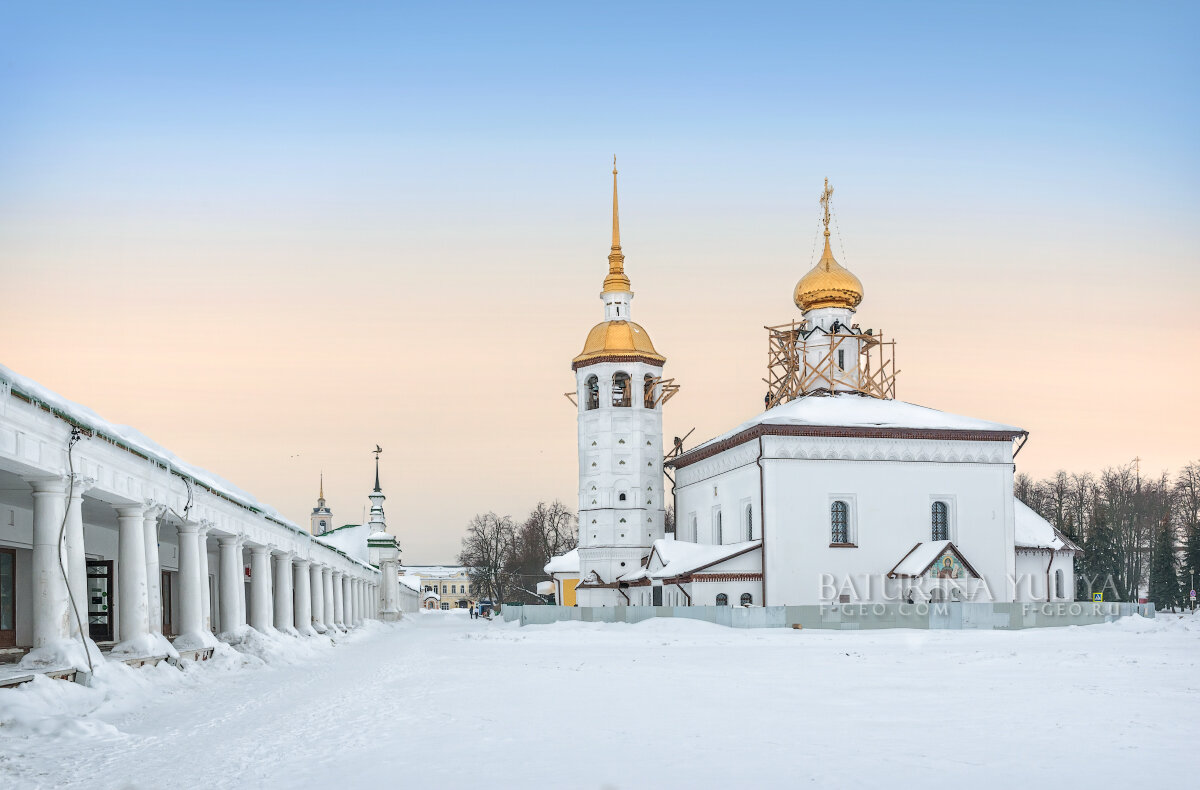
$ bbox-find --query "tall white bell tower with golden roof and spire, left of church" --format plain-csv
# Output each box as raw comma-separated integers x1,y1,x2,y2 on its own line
568,157,678,606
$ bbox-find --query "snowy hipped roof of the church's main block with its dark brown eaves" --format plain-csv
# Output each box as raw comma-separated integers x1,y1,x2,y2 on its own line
671,393,1025,466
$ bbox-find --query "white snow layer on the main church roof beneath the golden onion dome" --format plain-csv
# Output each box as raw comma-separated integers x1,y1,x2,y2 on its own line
690,393,1022,453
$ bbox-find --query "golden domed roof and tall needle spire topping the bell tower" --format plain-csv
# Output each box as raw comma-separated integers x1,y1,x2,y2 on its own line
571,157,666,370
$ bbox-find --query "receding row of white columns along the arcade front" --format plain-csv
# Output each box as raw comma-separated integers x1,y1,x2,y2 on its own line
28,475,379,656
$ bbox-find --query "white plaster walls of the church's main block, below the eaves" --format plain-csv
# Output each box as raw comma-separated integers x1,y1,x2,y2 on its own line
676,437,1014,605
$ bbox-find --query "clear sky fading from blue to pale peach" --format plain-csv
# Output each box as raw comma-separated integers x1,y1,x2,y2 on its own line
0,2,1200,564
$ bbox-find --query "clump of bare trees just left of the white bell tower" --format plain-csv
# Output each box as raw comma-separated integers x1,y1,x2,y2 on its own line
458,499,578,604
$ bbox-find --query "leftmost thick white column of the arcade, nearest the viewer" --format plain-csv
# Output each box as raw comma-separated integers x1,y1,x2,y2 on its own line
29,478,71,660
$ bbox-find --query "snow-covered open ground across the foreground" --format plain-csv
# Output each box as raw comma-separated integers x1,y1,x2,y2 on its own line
0,612,1200,790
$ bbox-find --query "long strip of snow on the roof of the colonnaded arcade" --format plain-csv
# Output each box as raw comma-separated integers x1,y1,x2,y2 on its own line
0,365,370,567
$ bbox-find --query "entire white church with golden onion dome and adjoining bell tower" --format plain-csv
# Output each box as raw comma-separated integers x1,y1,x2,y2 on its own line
559,168,1079,606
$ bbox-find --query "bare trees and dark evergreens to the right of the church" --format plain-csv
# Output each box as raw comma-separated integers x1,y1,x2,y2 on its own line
1015,461,1200,609
